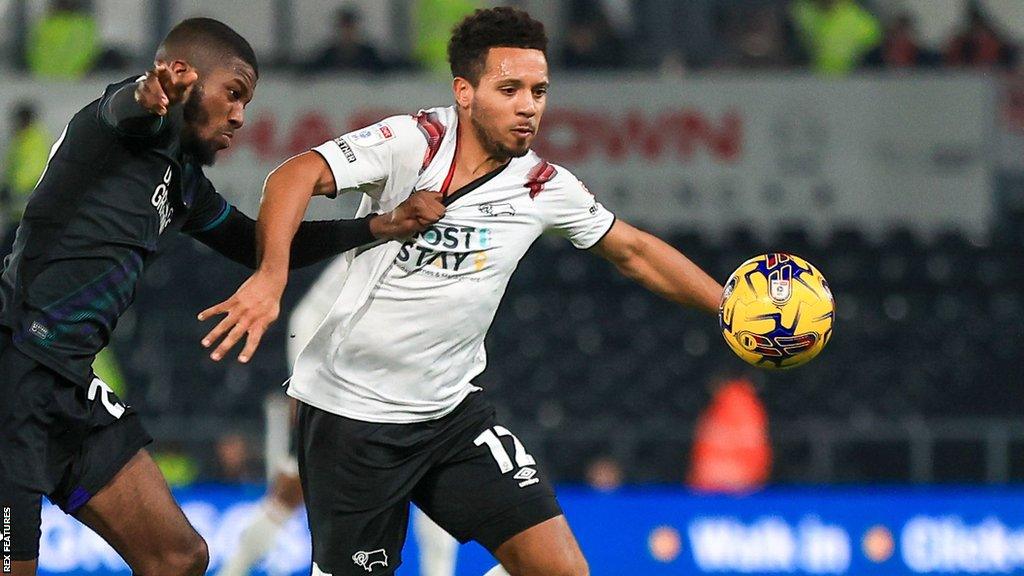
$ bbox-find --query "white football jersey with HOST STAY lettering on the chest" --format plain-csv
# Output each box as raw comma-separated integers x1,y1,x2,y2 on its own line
289,108,614,422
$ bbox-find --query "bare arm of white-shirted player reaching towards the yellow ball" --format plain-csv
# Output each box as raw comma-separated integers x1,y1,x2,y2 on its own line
593,220,722,314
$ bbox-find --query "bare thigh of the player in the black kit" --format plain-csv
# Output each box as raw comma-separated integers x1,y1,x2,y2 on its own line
75,450,209,575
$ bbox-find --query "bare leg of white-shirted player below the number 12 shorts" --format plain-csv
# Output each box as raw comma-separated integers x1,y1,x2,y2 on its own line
494,516,589,576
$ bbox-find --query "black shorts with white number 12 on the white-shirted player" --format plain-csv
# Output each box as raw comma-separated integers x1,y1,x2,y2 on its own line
298,393,562,576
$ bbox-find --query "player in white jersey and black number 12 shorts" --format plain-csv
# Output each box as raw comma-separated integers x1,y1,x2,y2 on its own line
208,7,722,576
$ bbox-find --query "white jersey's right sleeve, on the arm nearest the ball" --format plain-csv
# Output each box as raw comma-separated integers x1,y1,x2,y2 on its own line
537,167,615,250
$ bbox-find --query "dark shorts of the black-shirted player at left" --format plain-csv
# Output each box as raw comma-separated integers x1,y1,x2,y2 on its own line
0,328,152,561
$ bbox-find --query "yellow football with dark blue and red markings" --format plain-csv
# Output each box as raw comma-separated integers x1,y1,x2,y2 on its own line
718,253,836,369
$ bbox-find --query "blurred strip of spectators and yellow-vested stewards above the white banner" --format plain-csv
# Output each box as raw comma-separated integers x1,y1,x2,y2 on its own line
6,0,1024,79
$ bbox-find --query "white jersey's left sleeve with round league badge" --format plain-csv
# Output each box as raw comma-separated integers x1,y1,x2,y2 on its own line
312,116,427,196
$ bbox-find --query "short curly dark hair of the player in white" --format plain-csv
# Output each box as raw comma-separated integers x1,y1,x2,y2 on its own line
449,6,548,86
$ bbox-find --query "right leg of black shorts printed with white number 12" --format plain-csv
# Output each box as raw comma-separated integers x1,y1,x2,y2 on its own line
413,393,562,552
